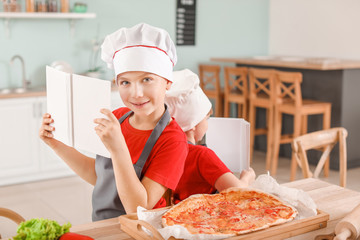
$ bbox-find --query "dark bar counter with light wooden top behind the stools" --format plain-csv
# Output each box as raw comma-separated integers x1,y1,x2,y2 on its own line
211,56,360,170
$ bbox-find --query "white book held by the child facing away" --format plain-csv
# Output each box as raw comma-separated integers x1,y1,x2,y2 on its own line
206,117,250,173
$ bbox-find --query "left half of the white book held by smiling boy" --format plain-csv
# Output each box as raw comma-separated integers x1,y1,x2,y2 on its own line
46,66,73,146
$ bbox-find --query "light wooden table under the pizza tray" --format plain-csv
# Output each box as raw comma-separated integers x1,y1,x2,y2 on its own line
71,178,360,240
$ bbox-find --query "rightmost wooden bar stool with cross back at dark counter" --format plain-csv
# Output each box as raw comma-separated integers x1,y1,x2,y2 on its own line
271,71,331,181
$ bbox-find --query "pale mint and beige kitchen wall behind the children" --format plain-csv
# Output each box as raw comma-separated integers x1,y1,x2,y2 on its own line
0,0,360,88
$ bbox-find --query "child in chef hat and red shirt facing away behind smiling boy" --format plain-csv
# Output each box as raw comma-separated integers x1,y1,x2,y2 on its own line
165,69,255,203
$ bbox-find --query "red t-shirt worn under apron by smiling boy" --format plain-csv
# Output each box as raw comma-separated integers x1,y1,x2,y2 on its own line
113,108,188,208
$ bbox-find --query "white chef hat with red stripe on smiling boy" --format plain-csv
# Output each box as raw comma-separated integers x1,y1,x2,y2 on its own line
101,23,177,81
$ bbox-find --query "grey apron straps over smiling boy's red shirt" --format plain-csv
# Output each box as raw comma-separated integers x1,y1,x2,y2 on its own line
119,104,170,180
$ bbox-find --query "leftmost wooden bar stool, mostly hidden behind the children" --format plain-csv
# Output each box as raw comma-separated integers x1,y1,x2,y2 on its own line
199,64,224,117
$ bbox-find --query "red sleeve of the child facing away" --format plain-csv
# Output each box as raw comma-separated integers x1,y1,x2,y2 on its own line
198,147,231,186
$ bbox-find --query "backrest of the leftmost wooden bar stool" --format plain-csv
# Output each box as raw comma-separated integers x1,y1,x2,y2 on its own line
199,64,221,94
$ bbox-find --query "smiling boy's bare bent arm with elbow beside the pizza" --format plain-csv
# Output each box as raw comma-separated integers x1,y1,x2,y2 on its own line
95,109,167,213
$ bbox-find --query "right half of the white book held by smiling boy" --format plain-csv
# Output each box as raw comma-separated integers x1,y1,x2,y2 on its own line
72,74,111,157
